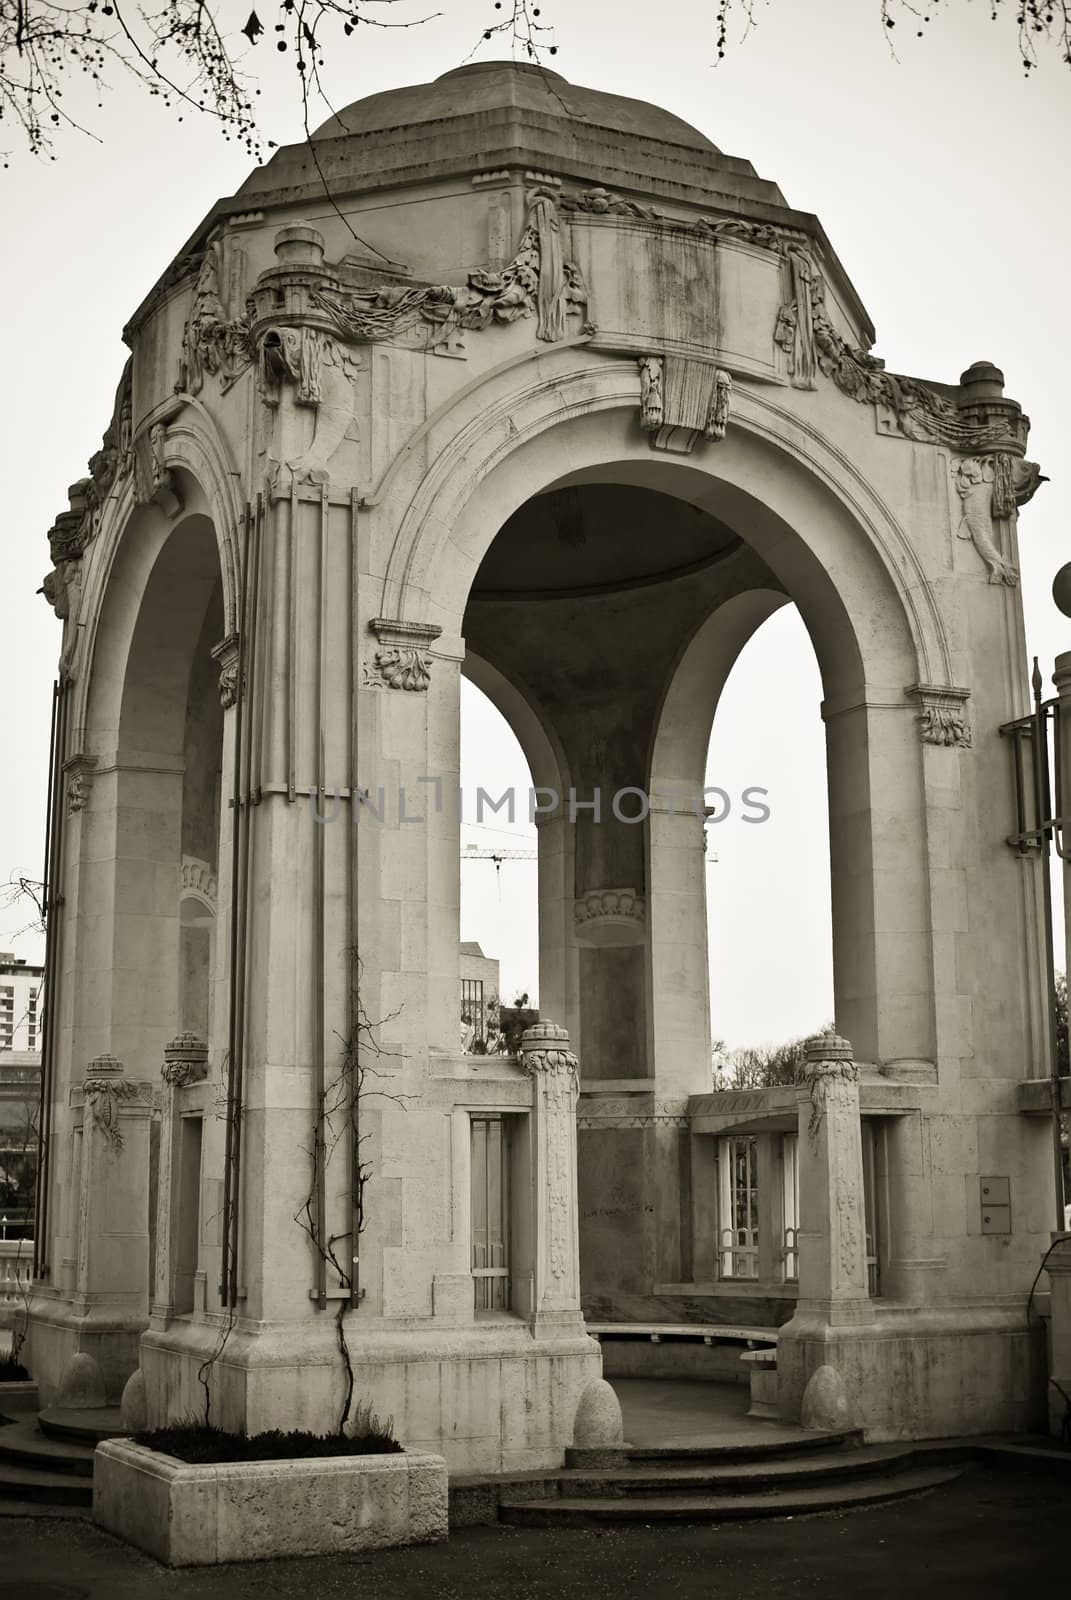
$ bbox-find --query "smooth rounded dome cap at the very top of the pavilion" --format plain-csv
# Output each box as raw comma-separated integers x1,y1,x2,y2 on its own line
312,61,719,155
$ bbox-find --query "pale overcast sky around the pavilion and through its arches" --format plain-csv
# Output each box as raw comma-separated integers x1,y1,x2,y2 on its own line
0,0,1071,1043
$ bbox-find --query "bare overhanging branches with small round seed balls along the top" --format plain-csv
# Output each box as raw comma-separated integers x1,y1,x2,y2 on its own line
0,0,1071,165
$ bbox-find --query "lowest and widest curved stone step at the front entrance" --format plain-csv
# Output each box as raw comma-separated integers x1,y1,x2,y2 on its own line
498,1466,965,1528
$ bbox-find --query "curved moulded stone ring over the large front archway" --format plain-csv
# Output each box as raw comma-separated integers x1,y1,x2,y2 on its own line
376,363,953,693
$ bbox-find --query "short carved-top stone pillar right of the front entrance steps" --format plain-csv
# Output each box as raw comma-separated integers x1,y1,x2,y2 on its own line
799,1034,871,1326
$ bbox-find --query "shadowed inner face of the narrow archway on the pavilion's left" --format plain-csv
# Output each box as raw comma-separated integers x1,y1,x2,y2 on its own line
75,502,226,1075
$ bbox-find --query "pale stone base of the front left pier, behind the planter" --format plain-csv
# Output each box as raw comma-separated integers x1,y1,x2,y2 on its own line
141,1314,602,1472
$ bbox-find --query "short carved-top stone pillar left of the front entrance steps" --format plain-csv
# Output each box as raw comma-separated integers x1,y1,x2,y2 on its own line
520,1022,583,1336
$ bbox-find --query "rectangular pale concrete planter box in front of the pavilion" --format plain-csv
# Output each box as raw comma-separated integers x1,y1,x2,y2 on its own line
93,1438,447,1566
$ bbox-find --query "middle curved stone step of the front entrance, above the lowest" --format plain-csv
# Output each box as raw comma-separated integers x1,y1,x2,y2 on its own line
556,1445,922,1499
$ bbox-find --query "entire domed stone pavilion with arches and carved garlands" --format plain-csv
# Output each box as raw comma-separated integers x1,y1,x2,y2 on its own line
29,62,1052,1465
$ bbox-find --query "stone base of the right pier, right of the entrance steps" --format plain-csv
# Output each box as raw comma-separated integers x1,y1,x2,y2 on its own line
776,1304,1045,1440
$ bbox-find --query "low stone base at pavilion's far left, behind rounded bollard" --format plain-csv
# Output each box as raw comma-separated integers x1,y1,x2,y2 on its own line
19,1286,146,1408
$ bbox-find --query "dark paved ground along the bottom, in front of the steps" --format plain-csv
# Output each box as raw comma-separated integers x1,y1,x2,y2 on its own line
0,1467,1071,1600
